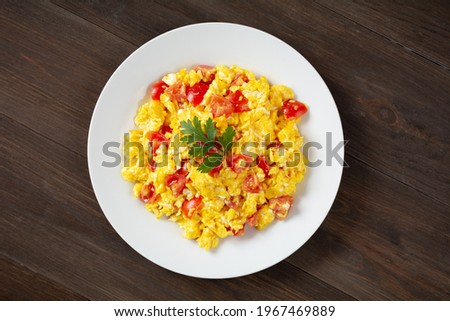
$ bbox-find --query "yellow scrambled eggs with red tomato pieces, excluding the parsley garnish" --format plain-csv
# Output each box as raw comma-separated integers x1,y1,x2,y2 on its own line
122,65,306,250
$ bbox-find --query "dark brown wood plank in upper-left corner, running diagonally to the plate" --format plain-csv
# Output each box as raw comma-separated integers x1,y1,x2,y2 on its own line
0,1,136,138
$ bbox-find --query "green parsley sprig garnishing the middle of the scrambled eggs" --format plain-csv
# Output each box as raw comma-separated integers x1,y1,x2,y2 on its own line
180,116,236,173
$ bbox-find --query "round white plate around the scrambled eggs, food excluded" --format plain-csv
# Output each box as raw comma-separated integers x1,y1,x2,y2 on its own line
88,23,344,278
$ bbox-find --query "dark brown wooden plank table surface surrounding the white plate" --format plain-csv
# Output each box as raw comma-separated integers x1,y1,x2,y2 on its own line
0,0,450,300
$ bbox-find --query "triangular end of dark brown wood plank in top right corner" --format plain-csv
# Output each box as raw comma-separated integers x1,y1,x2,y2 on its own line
316,0,450,70
